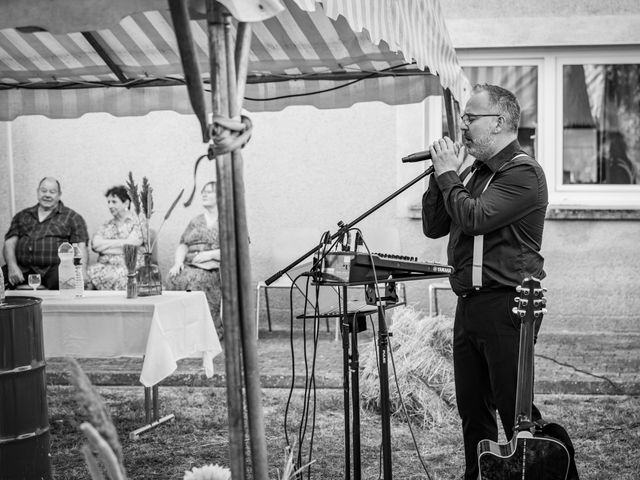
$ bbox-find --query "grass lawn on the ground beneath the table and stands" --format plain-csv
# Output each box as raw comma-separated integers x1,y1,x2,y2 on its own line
47,386,640,480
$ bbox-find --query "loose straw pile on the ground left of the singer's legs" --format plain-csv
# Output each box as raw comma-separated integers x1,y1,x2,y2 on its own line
360,307,455,428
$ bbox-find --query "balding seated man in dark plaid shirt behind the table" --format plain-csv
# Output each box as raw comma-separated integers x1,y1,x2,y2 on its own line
2,177,89,290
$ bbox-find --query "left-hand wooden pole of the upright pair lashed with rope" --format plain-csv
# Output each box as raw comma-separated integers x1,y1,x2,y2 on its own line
206,0,246,480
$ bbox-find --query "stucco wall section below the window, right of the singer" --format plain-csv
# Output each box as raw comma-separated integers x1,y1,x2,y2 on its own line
543,220,640,333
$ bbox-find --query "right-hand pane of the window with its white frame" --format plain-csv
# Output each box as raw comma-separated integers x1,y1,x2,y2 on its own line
546,51,640,210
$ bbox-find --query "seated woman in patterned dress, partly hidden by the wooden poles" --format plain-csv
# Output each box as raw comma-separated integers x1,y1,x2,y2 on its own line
166,182,223,340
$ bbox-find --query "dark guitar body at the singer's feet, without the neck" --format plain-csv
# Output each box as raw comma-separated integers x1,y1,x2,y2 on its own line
478,432,571,480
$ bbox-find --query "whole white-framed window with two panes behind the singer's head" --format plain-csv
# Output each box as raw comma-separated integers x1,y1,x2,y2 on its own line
459,46,640,212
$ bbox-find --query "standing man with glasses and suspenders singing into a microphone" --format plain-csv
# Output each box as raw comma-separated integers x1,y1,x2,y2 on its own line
422,85,548,480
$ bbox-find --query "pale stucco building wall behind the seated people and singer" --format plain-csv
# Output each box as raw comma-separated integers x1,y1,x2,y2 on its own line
0,103,640,332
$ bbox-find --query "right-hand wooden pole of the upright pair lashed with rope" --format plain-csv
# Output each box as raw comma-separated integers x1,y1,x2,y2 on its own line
224,14,269,480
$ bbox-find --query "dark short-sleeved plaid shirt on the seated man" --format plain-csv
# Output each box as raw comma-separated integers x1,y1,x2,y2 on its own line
4,202,89,270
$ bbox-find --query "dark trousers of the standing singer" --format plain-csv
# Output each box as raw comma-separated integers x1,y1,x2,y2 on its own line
453,289,540,480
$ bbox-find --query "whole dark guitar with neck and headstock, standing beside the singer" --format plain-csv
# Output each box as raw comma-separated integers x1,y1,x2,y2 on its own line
478,277,578,480
